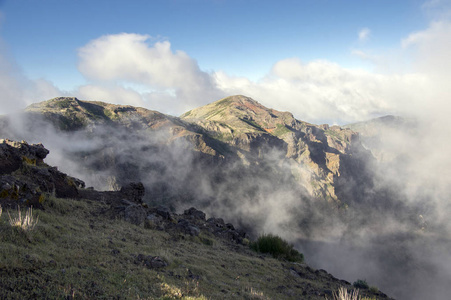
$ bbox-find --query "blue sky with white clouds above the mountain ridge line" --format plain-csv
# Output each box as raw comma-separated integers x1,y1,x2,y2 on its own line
0,0,449,123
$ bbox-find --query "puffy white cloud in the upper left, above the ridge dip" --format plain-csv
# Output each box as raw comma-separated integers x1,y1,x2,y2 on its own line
78,33,224,114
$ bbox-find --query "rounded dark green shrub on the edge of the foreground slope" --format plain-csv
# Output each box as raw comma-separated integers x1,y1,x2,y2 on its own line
250,234,304,262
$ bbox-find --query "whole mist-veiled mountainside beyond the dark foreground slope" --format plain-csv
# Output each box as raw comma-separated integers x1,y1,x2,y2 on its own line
0,96,434,299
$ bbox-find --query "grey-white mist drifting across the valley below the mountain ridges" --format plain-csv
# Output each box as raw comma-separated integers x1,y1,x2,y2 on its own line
1,96,451,299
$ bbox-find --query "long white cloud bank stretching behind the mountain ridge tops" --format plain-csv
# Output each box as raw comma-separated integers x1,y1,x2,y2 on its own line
69,21,451,124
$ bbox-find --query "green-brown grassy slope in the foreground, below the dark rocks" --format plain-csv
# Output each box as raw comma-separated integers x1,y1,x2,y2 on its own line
0,193,388,299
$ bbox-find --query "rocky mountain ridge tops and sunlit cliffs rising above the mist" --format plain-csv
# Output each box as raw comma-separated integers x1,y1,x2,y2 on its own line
2,96,371,204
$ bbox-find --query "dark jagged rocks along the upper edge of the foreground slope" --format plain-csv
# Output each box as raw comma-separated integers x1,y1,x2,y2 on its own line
0,140,251,245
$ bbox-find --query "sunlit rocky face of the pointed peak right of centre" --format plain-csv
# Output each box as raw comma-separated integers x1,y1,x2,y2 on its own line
181,96,372,203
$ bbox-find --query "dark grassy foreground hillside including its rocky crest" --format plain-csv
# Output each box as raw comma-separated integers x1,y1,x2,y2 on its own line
0,140,388,299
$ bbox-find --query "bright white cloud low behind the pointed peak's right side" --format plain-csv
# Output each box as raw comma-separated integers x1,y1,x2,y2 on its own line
216,58,425,123
